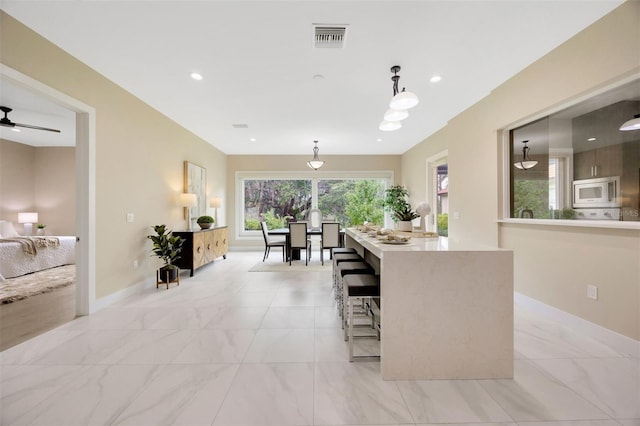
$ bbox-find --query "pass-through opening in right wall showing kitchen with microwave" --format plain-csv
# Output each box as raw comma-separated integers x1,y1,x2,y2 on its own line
509,80,640,221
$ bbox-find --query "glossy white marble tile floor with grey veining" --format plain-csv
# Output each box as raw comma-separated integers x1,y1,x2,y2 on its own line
0,252,640,426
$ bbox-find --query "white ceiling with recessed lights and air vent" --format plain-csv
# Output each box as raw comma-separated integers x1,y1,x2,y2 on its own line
0,0,622,157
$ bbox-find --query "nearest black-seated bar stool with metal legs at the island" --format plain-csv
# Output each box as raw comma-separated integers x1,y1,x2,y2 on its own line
343,274,380,362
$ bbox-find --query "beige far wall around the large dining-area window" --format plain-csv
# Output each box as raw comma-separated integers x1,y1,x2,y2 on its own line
228,155,400,248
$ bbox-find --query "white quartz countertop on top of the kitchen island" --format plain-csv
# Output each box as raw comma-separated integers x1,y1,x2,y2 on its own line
346,228,502,257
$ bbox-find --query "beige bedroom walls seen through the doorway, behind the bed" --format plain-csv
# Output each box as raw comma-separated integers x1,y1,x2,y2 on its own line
0,140,76,235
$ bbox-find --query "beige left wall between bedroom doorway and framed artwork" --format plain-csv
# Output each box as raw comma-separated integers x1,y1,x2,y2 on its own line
0,12,226,298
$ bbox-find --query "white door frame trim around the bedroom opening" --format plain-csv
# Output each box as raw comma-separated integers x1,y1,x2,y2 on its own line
0,64,95,316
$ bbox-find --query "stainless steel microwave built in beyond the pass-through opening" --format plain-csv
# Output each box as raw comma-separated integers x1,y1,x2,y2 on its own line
573,176,620,209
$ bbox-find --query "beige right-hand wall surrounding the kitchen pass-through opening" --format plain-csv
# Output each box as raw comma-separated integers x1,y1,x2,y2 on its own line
402,1,640,339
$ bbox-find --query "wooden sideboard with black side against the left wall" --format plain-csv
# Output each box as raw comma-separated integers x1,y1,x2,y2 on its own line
173,226,229,276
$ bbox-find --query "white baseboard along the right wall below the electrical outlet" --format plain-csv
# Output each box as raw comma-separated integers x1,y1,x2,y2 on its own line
513,292,640,358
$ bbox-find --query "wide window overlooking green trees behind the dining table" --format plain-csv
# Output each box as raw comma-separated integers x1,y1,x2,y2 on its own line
236,172,392,236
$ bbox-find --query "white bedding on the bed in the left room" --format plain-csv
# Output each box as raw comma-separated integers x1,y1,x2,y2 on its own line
0,236,76,281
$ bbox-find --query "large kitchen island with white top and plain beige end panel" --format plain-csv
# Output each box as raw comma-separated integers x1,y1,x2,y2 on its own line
346,229,513,380
